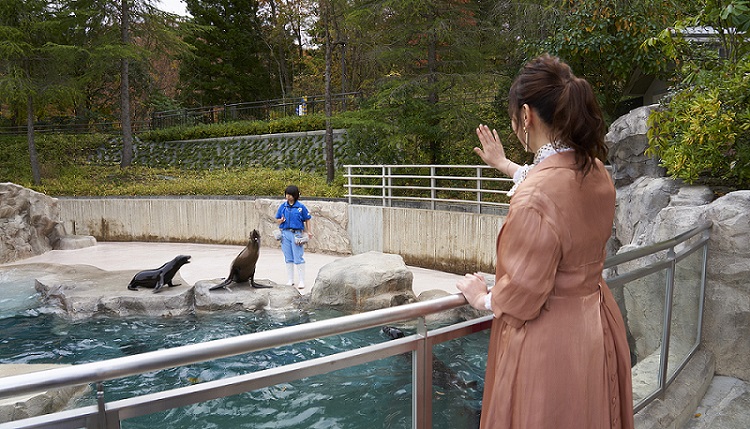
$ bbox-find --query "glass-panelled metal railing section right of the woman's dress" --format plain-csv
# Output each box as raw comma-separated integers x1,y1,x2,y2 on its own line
604,221,713,412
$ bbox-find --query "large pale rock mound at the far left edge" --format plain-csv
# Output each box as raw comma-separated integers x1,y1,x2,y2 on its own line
0,183,64,263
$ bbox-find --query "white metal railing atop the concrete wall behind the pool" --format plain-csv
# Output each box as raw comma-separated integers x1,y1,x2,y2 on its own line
344,165,513,213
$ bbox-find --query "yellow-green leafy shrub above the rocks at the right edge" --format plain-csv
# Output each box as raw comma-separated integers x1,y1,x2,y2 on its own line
647,59,750,187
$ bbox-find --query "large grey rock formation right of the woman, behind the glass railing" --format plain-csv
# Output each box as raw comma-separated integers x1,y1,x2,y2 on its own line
607,108,750,380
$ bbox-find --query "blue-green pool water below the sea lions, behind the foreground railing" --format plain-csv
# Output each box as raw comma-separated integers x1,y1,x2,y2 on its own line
0,270,488,429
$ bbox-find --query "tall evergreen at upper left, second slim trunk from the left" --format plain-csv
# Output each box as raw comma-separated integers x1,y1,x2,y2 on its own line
60,0,186,167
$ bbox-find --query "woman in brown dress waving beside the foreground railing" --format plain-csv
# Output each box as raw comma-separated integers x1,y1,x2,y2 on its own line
457,55,633,429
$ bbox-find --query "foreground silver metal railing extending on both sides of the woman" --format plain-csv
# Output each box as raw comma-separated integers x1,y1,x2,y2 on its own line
0,222,712,429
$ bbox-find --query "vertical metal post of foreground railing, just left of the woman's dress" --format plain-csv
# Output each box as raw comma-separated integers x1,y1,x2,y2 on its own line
411,317,432,429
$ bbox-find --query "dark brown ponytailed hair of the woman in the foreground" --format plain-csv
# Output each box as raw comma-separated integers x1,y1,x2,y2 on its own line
508,54,607,174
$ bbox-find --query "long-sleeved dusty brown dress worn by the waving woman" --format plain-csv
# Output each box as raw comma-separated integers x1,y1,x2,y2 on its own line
481,152,633,429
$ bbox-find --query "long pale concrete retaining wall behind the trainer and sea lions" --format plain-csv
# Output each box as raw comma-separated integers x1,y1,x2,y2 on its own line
58,197,503,274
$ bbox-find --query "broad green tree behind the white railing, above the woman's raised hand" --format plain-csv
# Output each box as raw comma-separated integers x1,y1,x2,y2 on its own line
345,0,485,164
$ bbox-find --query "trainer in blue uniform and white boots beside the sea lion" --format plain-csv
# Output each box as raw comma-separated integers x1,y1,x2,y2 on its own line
276,185,312,289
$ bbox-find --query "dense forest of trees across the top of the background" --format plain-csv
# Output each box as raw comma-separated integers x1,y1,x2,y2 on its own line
0,0,750,190
